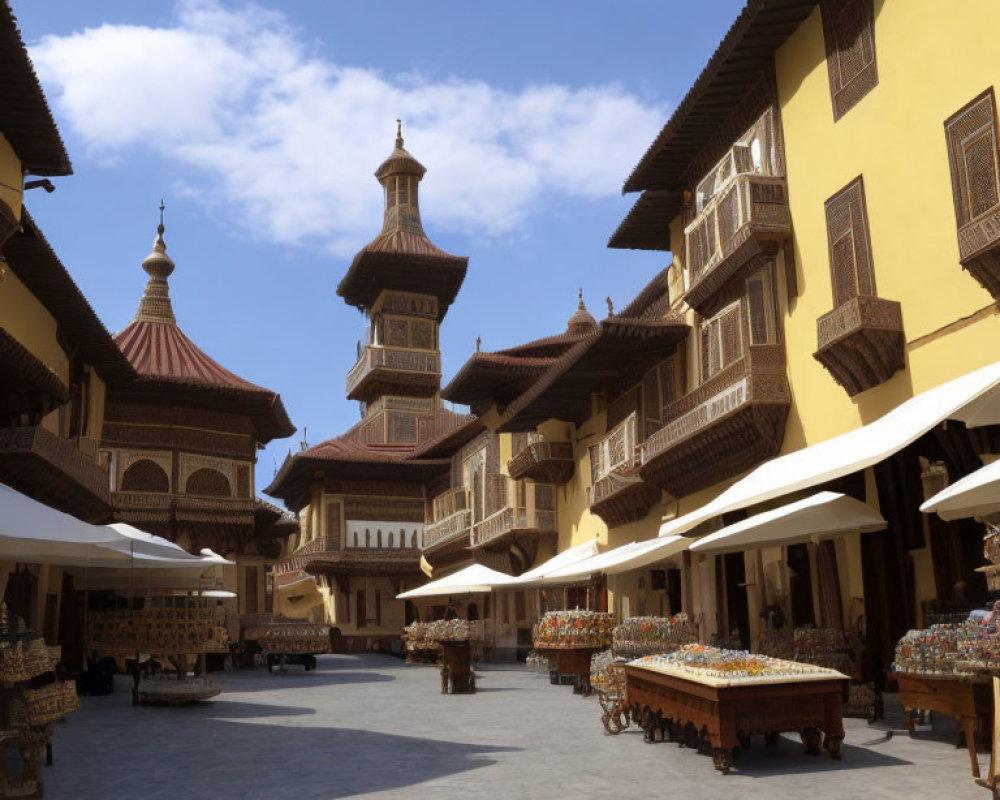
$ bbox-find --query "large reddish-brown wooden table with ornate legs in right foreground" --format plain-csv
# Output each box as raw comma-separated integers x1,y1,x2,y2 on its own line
624,664,847,774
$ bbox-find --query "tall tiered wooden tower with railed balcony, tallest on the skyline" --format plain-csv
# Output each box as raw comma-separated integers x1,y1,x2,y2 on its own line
337,126,468,447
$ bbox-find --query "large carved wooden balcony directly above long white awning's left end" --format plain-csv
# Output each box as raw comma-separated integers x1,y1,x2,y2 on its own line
639,345,791,497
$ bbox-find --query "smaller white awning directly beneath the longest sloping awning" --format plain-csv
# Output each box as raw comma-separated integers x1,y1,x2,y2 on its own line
691,492,887,553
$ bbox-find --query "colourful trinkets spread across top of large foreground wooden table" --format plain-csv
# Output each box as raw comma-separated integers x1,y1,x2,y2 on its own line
630,644,847,686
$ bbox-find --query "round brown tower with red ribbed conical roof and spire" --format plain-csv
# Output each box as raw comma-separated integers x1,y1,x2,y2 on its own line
100,205,295,568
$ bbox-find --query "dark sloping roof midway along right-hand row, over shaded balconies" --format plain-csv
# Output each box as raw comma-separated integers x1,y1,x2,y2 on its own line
498,317,690,431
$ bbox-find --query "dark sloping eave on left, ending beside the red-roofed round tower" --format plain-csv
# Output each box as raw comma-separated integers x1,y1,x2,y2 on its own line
0,211,135,382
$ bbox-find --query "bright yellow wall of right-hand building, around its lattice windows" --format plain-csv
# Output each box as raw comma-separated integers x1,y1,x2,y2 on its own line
775,0,1000,452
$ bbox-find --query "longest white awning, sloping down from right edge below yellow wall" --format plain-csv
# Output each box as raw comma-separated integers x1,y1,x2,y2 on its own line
660,362,1000,536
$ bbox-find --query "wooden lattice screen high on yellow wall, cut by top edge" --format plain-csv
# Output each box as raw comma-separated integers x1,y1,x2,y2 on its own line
821,0,878,121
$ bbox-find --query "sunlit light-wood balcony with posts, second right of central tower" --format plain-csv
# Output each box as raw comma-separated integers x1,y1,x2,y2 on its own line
469,473,556,548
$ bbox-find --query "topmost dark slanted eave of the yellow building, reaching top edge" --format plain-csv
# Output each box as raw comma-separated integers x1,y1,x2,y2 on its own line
623,0,817,192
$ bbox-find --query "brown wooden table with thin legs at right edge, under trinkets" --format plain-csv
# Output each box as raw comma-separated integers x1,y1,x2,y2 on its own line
896,672,993,778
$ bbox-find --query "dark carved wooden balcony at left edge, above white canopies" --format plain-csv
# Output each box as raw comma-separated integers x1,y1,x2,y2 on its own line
0,425,111,522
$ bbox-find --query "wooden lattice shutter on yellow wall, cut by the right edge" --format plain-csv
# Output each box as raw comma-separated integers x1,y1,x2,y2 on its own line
944,88,1000,228
